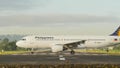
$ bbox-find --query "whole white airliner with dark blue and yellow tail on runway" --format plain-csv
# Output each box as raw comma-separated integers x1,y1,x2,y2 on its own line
16,27,120,54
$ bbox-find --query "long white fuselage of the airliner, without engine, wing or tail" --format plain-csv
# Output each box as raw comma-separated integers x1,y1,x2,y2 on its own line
17,36,120,48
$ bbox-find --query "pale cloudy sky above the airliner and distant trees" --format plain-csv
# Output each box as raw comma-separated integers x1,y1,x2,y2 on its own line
0,0,120,35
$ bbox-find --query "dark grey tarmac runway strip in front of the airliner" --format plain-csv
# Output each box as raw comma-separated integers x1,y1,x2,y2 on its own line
0,54,120,64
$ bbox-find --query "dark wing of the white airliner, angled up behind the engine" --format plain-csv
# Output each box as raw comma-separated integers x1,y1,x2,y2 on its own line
63,40,86,50
